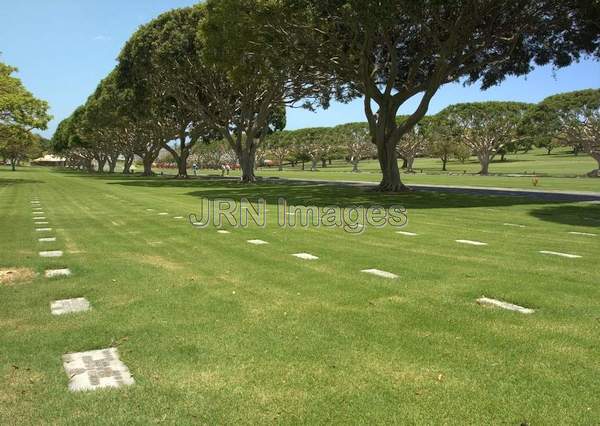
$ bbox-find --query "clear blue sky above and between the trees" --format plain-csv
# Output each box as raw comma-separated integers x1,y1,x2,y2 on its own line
0,0,600,136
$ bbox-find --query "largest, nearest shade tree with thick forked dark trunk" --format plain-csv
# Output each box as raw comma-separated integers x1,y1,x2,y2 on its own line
292,0,599,191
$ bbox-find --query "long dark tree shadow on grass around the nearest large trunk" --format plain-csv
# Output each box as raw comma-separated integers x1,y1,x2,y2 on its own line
101,177,584,209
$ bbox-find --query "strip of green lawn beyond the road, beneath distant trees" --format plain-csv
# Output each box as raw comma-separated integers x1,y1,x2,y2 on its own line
182,149,600,192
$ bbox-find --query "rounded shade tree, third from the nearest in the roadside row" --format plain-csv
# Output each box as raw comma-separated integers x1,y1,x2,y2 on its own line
116,6,209,177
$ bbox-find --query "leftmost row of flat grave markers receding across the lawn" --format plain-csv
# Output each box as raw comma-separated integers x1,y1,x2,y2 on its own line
31,197,134,391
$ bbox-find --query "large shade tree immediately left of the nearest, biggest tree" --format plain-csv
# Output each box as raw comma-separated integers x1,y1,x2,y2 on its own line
196,0,331,182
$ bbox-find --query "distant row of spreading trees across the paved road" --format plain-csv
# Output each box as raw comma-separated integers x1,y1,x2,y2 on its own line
246,89,600,176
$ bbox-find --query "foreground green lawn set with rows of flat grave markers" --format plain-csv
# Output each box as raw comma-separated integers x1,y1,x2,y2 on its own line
0,165,600,425
